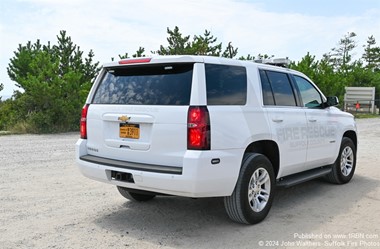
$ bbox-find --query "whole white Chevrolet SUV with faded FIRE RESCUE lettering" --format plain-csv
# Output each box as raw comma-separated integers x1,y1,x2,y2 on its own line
76,56,357,224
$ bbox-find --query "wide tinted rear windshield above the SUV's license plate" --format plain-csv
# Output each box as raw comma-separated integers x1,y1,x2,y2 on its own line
93,63,194,105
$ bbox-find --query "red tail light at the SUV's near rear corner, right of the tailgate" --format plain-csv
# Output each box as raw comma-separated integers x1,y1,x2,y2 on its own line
187,106,211,150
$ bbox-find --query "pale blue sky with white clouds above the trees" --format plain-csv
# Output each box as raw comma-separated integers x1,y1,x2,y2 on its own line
0,0,380,96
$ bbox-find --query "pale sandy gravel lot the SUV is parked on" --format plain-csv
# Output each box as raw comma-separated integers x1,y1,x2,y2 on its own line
0,119,380,248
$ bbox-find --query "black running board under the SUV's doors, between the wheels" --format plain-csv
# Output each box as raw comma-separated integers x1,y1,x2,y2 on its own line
276,166,332,188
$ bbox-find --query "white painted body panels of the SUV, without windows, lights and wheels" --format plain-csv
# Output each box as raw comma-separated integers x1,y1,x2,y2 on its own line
76,56,356,197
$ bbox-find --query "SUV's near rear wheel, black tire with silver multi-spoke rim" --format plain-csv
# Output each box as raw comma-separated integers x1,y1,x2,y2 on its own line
224,153,275,224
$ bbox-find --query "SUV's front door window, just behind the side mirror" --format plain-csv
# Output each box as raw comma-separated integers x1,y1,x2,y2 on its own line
294,75,323,108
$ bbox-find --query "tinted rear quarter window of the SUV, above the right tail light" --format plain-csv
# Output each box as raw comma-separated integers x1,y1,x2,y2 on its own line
205,64,247,105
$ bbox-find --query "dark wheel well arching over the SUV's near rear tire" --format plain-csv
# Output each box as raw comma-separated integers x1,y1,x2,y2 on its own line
244,140,280,177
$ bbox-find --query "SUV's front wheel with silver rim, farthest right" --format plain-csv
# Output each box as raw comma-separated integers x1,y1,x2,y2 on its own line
326,137,356,184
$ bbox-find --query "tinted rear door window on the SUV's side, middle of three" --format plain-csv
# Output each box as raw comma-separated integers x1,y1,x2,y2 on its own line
266,71,297,106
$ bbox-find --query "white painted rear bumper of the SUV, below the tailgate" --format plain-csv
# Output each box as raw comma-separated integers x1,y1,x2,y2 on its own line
76,139,244,197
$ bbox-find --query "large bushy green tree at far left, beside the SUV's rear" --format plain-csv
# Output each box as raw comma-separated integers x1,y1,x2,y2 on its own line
7,31,99,132
